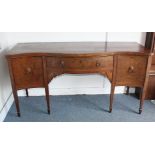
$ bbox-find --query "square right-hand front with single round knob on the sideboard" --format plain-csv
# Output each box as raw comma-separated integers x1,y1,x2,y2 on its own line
116,56,148,87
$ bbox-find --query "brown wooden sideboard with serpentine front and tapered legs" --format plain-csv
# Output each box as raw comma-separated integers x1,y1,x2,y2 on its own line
6,42,152,116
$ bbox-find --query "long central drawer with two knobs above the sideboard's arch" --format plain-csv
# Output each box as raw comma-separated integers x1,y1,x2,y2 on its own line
47,56,113,70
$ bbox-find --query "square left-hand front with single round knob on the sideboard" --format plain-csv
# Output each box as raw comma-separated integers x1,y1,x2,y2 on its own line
11,57,44,89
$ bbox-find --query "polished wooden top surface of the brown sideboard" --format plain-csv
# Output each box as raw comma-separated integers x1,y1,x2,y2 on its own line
7,42,148,56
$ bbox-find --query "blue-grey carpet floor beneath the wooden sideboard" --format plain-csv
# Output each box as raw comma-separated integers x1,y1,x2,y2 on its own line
5,95,155,122
